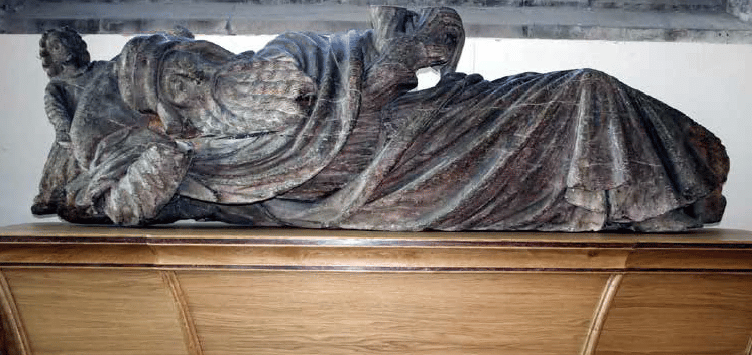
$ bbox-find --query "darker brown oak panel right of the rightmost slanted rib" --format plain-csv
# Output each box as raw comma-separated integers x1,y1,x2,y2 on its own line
596,274,752,355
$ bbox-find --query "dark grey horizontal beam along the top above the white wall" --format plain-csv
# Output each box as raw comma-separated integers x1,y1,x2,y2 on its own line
0,0,752,44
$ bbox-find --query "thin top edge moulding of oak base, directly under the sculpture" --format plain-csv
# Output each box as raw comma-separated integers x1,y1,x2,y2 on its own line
0,223,752,246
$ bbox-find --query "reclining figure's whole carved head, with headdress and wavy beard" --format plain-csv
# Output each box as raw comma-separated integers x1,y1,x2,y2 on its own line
116,34,315,138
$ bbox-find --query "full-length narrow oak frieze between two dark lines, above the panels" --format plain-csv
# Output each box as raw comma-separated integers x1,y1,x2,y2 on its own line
0,243,752,272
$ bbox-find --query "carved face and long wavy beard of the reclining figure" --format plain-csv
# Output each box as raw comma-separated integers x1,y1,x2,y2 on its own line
157,42,316,136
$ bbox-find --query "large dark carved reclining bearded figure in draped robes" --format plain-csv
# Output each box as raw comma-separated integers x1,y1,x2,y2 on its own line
33,7,729,231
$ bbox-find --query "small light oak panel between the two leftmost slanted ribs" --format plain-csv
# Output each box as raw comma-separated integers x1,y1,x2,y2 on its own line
3,269,186,355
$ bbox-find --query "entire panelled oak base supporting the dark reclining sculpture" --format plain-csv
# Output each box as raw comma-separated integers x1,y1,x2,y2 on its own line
0,224,752,355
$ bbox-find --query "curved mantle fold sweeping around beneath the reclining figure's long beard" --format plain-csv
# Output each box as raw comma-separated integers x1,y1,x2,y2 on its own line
179,31,370,203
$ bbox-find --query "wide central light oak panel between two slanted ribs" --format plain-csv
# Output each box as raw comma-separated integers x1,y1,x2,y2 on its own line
178,271,608,355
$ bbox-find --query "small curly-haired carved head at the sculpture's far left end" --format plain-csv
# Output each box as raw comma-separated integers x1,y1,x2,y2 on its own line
39,27,91,78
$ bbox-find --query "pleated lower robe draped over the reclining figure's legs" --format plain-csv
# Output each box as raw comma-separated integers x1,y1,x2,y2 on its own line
264,69,727,231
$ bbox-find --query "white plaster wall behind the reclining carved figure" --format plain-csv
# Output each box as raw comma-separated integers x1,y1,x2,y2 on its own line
0,35,752,230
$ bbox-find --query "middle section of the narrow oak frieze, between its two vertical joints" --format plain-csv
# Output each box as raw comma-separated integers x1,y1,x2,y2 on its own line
153,246,632,271
